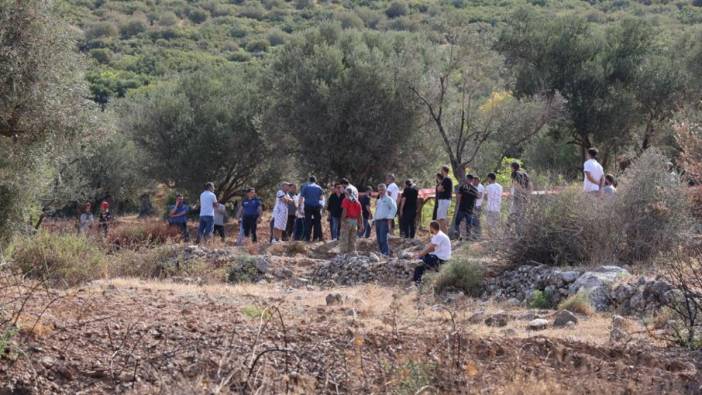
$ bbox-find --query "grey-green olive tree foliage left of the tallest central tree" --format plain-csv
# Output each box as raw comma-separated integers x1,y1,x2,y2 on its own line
120,67,278,202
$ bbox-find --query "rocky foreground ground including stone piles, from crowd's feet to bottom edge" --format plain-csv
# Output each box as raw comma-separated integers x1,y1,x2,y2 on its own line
0,240,702,394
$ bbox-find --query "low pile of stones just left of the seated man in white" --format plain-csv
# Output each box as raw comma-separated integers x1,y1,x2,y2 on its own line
310,252,418,285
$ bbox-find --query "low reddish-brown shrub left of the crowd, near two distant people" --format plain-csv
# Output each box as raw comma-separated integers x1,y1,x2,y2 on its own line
107,221,180,249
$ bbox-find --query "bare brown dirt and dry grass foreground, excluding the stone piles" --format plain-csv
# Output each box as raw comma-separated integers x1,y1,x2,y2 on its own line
0,279,702,394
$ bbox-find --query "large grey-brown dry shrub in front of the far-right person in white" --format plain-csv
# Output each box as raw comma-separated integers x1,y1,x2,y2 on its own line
502,149,692,265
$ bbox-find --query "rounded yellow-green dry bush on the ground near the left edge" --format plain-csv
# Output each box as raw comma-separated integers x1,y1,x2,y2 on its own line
9,232,106,286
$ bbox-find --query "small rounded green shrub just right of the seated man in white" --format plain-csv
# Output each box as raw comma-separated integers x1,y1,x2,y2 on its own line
434,257,484,296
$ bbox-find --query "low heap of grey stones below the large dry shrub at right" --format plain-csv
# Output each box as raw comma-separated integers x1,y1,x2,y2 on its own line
485,265,678,315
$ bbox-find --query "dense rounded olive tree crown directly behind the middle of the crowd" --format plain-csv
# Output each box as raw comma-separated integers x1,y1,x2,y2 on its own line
265,24,428,183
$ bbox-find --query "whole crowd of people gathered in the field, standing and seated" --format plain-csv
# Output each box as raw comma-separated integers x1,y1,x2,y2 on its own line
79,148,616,283
